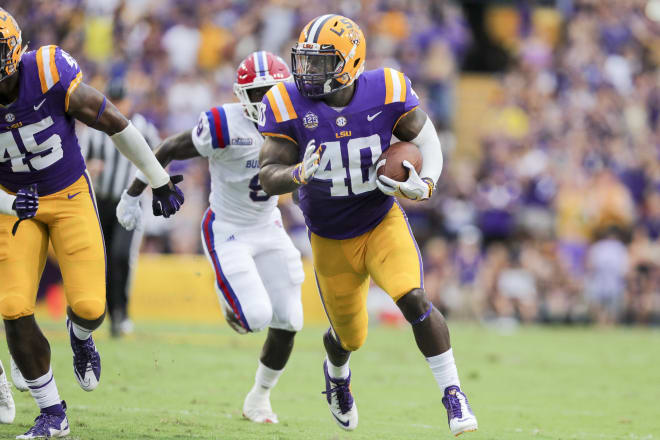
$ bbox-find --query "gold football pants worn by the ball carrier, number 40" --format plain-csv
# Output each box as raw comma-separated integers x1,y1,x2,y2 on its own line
310,203,424,351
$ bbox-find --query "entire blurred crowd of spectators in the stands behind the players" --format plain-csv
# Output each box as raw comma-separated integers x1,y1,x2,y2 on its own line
9,0,660,325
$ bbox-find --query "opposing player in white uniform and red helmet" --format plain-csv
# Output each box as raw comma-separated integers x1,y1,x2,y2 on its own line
117,51,304,423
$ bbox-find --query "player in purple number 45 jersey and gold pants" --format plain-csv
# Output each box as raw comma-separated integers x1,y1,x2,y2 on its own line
0,8,183,439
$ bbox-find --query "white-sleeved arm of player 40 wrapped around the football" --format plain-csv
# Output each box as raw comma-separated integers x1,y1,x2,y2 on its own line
377,107,443,200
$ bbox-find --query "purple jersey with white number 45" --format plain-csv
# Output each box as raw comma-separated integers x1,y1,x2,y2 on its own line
0,46,85,195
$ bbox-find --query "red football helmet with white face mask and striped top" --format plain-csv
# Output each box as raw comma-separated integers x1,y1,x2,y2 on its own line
234,50,293,123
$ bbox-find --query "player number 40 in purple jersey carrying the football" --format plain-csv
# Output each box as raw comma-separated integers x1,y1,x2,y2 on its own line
259,14,477,435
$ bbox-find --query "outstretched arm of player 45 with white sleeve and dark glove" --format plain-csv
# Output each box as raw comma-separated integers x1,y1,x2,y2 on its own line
67,83,184,217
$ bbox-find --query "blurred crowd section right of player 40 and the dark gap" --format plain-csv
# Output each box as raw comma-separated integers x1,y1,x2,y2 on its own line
416,0,660,324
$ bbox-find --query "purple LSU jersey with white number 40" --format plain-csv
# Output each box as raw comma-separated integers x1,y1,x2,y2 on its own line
259,68,419,239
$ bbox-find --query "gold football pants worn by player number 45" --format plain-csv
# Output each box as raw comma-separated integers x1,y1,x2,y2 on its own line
0,172,106,320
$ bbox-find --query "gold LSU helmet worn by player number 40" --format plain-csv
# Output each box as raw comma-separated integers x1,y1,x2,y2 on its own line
291,14,367,98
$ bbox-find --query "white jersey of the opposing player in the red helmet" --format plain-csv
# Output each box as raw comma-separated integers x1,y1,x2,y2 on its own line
192,103,280,226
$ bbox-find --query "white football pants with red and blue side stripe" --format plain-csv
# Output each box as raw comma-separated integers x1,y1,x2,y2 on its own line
202,208,305,332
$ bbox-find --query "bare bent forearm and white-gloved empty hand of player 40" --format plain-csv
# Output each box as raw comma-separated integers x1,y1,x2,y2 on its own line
259,136,325,195
